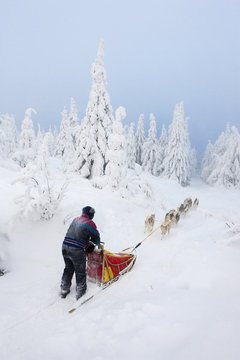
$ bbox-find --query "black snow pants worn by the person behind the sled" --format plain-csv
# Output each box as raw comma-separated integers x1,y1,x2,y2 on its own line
61,244,87,295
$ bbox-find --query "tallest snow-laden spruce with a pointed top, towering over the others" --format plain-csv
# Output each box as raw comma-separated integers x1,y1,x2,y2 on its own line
75,40,113,178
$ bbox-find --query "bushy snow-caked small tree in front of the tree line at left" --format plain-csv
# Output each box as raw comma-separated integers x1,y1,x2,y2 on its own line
13,133,67,220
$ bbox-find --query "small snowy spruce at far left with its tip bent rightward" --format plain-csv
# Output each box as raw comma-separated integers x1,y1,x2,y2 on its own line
13,108,37,167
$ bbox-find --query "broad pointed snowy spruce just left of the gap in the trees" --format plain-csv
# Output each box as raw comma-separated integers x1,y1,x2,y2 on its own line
164,102,191,186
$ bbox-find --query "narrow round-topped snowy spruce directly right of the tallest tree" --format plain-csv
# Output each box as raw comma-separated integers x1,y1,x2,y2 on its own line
106,106,127,189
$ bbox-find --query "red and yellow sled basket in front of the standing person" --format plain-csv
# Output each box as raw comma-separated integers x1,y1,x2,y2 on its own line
87,250,136,285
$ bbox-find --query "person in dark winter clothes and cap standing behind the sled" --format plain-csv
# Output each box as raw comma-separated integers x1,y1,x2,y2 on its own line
60,206,100,300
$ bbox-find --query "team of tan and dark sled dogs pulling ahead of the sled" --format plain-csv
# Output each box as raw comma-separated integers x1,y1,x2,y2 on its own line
144,197,199,236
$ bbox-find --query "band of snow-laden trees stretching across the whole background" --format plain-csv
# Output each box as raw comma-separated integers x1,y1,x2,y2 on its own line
0,41,240,219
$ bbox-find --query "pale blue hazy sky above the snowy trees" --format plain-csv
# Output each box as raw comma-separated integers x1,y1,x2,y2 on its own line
0,0,240,153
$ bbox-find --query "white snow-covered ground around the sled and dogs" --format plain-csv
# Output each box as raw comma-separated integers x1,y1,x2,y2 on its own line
0,162,240,360
